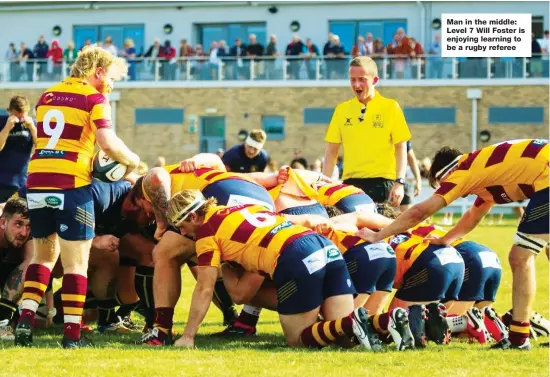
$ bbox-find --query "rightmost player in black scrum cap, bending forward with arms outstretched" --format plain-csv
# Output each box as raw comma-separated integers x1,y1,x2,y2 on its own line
361,139,550,350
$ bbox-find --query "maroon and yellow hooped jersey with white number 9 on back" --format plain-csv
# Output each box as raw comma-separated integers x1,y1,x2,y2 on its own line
27,77,112,190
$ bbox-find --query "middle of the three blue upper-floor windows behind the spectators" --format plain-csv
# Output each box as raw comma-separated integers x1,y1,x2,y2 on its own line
195,23,267,47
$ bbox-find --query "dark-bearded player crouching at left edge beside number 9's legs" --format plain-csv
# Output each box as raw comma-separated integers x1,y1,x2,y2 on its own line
0,198,32,340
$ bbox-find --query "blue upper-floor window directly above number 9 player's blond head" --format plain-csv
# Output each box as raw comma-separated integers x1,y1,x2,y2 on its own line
73,25,145,55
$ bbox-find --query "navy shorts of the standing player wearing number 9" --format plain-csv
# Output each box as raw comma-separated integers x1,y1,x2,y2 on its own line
27,185,95,241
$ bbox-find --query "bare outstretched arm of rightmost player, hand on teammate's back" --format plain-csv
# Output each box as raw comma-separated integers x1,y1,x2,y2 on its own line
357,195,447,242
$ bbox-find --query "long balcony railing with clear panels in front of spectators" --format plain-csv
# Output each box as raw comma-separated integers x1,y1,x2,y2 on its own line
0,55,549,82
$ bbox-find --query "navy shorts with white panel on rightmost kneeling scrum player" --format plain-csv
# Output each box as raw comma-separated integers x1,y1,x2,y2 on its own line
455,241,502,301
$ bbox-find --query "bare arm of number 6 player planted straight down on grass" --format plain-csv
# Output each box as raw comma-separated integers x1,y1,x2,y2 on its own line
182,266,218,340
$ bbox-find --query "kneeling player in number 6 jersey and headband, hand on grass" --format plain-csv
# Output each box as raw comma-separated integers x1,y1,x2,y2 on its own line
168,190,380,349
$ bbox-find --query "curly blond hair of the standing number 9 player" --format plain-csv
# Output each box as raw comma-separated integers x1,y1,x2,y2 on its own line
71,46,128,80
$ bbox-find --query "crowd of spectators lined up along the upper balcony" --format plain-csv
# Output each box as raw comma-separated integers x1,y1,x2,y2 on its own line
5,28,548,81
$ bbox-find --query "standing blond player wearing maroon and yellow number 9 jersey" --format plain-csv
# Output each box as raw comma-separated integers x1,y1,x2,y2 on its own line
15,47,139,348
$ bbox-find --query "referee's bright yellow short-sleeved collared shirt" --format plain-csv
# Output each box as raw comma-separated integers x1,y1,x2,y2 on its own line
325,91,411,180
